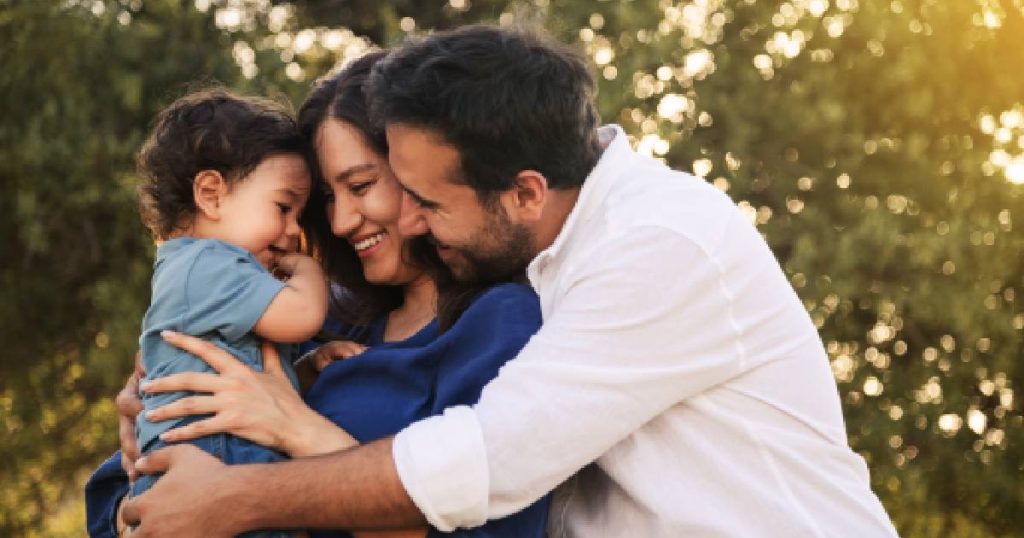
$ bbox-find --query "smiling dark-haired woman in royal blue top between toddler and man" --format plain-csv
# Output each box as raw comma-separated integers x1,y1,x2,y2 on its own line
86,52,549,537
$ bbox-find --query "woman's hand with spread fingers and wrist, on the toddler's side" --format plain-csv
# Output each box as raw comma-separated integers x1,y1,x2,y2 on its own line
143,331,358,457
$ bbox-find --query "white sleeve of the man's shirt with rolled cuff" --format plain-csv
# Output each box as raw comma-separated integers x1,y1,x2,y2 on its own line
394,226,745,529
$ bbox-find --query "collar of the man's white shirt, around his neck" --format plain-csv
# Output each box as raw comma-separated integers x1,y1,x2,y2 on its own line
526,125,633,278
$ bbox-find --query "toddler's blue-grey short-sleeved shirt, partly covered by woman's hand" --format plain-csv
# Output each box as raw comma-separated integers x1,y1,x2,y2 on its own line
135,237,297,450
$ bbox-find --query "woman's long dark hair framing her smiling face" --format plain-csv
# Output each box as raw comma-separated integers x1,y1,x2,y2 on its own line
298,50,483,331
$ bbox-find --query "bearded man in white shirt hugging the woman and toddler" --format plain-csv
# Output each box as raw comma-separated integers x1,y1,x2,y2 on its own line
124,27,895,537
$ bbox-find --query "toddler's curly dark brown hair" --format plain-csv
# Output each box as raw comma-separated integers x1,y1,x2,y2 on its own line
136,88,311,240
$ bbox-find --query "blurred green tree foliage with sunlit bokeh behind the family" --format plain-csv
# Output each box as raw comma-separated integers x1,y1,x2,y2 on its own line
0,0,1024,536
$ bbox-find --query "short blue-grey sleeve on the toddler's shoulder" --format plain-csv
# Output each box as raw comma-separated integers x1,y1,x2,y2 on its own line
182,242,285,341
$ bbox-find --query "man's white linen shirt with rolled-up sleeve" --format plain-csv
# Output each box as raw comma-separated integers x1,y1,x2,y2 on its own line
393,126,896,538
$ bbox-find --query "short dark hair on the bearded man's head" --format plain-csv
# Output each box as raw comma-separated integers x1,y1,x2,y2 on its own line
367,26,601,202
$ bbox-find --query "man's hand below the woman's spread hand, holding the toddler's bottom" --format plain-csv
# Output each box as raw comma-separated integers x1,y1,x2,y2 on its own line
121,445,245,538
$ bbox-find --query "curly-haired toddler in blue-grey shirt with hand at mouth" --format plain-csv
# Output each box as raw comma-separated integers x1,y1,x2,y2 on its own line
132,89,328,536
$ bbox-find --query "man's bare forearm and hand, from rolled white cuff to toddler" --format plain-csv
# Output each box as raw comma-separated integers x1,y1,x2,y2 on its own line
123,438,426,537
